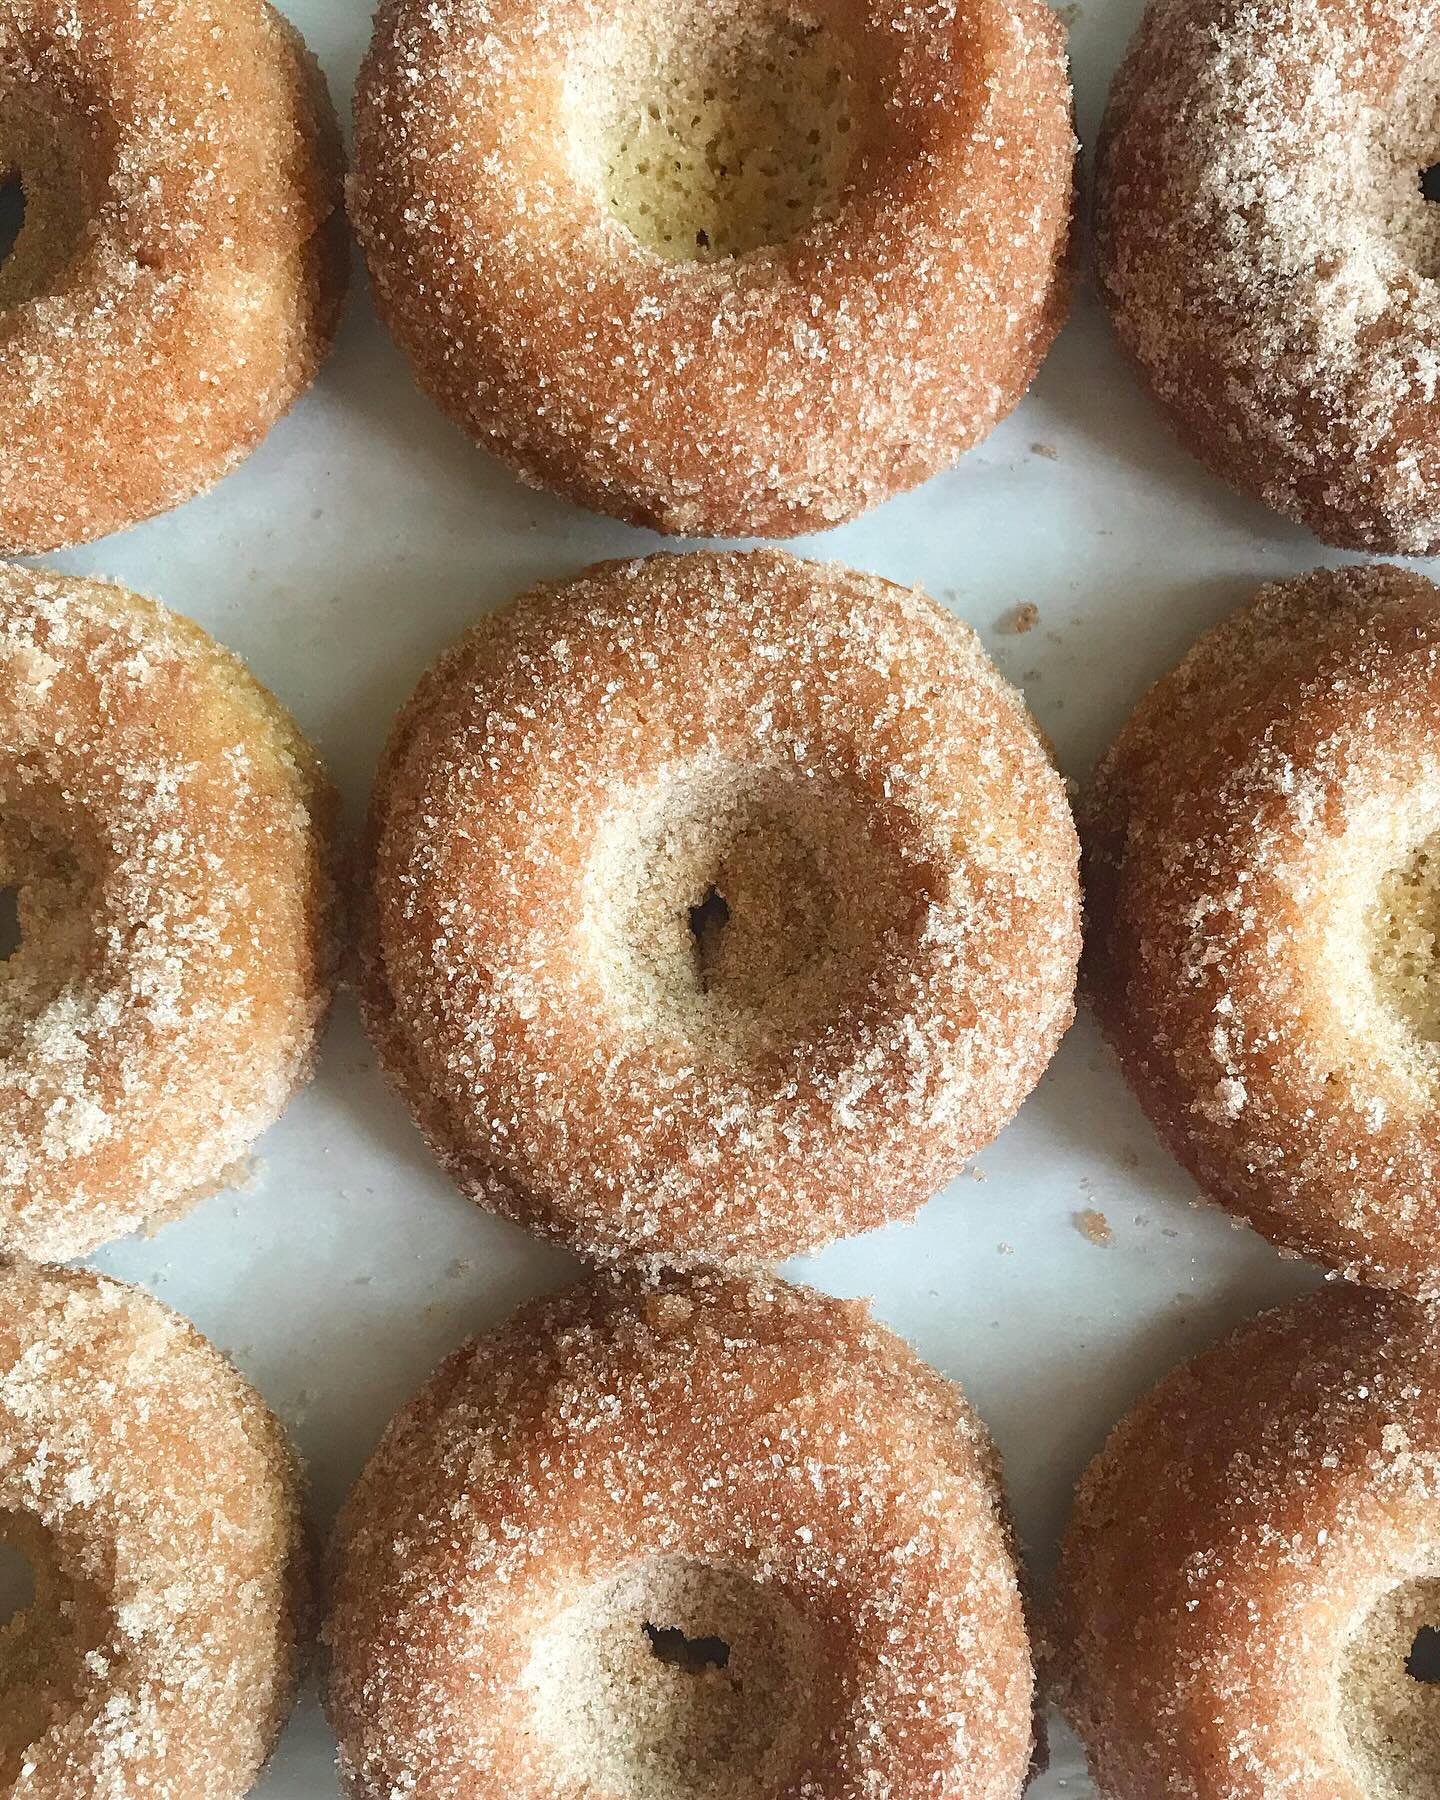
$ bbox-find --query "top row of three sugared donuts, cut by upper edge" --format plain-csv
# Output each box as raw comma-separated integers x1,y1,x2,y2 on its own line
0,0,1440,554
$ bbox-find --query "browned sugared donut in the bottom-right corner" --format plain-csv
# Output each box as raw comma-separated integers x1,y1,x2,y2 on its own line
1058,1287,1440,1800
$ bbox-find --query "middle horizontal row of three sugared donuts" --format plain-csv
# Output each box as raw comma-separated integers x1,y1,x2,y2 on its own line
19,551,1440,1300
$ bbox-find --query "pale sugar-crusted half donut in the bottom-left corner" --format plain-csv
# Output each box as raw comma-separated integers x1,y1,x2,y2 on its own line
0,1265,308,1800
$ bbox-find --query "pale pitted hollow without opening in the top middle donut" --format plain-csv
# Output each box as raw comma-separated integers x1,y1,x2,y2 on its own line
569,0,857,263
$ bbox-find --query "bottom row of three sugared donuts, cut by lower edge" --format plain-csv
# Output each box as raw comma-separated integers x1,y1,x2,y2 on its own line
16,1265,1440,1800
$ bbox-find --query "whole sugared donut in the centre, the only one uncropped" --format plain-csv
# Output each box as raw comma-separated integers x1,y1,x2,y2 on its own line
360,551,1078,1265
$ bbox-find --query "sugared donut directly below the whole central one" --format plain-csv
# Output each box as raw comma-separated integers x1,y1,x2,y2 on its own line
326,1276,1035,1800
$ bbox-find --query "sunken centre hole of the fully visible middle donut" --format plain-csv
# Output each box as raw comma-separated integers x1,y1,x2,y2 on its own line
583,765,929,1062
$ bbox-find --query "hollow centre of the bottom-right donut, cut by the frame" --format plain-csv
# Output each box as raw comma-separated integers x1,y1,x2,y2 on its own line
1339,1577,1440,1800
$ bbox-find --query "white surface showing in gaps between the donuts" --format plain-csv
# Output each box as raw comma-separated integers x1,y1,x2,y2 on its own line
28,0,1440,1800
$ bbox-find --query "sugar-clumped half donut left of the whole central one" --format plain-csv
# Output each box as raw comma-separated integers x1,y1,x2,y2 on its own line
0,565,335,1260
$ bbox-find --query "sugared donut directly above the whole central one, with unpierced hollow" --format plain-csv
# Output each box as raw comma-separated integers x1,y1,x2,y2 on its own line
351,0,1075,536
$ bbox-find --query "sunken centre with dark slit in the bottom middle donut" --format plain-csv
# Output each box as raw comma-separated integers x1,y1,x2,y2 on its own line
526,1557,823,1800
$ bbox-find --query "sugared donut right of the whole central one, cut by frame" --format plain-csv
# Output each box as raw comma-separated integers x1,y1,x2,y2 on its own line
1084,567,1440,1298
